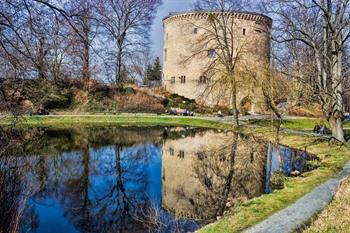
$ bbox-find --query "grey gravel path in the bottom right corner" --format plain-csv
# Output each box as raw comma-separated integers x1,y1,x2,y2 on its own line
245,162,350,233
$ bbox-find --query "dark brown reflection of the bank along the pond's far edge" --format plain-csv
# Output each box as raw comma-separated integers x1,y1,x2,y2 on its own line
24,127,163,155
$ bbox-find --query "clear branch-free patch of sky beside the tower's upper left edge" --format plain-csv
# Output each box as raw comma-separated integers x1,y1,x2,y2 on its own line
151,0,194,58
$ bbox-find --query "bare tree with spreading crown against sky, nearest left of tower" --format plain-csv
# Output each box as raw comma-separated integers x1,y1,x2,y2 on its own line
97,0,161,84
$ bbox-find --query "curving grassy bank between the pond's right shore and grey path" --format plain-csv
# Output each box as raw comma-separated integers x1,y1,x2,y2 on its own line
199,128,350,232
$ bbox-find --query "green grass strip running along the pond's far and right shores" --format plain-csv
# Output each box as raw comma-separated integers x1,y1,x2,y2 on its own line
2,115,350,232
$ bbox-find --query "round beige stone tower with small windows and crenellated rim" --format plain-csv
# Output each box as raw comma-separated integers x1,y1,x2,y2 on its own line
163,12,272,111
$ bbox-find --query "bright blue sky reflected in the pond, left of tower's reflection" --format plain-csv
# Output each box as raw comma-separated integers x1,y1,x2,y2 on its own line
22,143,161,233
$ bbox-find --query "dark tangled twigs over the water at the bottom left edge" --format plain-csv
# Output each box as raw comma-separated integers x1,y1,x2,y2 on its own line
0,127,41,233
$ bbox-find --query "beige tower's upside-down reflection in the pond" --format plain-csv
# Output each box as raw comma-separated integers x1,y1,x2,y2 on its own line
162,131,266,220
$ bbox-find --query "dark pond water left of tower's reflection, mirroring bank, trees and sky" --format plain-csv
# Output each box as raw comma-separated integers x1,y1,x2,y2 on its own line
0,129,170,232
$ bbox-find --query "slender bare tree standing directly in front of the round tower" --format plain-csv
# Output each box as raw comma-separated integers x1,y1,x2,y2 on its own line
185,0,270,125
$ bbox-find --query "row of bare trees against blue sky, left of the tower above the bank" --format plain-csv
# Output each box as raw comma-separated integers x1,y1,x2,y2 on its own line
0,0,161,89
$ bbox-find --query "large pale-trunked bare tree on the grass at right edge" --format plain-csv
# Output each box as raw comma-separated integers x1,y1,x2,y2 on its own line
263,0,350,141
